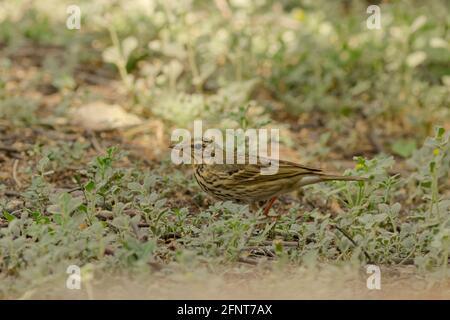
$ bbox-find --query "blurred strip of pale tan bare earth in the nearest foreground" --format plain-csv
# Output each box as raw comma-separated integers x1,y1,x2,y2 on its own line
14,264,450,299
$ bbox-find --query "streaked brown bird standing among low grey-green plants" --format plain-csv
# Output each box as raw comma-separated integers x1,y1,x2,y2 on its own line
170,139,366,216
